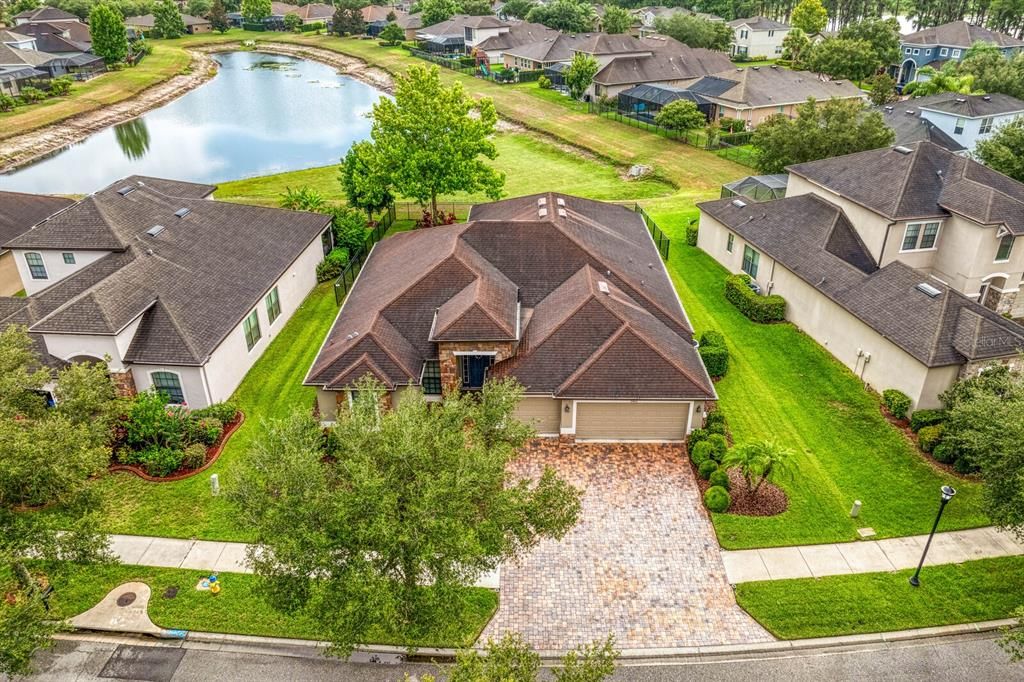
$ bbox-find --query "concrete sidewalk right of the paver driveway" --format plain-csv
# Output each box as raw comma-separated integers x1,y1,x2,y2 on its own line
722,527,1024,585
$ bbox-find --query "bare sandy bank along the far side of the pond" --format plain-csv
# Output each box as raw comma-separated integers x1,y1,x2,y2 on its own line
0,42,393,173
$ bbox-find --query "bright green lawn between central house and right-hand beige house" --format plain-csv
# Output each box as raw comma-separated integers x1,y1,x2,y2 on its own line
654,218,987,549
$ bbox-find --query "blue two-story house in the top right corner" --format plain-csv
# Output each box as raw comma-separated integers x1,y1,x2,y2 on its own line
894,22,1024,86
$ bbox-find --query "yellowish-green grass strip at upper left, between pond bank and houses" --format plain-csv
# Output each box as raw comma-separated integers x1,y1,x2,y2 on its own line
0,41,190,139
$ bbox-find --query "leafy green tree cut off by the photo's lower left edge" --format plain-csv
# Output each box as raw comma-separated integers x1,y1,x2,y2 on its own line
0,326,116,676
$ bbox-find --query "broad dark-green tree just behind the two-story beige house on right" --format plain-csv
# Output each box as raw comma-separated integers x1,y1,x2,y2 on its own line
751,97,895,173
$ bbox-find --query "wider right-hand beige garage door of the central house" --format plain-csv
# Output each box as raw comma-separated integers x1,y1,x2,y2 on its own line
575,402,690,440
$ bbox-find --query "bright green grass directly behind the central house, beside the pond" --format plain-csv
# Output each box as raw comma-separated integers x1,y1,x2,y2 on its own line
216,133,675,206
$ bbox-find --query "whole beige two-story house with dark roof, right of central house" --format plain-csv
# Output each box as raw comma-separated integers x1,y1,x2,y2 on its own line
697,142,1024,409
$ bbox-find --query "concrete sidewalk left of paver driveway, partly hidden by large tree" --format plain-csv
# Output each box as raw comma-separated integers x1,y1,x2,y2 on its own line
109,536,501,590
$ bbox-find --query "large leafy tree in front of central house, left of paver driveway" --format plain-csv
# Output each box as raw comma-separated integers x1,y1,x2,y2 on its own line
232,379,580,653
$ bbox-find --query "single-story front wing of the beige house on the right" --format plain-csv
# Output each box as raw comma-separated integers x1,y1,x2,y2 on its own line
697,173,1024,409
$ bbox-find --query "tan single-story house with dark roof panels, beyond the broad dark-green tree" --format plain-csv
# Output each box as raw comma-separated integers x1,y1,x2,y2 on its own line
686,66,866,129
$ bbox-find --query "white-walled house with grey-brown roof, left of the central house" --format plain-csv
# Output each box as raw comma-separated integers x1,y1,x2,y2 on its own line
0,176,330,407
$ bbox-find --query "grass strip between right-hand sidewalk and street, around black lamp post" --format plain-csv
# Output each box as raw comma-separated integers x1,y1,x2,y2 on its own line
736,556,1024,639
